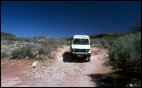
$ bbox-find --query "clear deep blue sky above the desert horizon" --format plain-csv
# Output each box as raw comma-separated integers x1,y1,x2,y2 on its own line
1,1,141,38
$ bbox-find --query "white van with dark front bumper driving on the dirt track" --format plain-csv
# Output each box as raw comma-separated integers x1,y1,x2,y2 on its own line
69,35,91,61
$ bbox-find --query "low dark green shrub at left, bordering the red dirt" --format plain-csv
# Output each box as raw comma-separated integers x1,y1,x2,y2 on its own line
12,46,33,58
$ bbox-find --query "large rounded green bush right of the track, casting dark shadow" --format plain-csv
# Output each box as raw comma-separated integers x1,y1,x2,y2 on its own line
109,32,141,77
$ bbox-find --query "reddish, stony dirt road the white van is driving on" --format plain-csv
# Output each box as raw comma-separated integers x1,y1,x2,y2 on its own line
1,46,111,87
